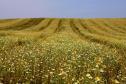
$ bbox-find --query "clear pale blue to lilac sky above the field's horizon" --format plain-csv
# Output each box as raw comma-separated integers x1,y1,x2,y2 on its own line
0,0,126,18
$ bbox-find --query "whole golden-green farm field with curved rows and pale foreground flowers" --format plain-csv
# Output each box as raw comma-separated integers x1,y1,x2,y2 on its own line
0,18,126,84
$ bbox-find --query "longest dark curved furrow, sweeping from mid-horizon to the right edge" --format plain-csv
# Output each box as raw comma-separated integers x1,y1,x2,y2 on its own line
71,18,126,57
